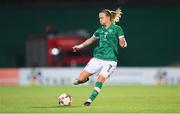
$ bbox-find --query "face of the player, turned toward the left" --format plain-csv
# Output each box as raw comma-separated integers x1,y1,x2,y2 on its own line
99,12,110,25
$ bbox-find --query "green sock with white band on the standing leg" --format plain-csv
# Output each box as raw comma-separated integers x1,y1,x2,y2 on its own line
89,82,103,101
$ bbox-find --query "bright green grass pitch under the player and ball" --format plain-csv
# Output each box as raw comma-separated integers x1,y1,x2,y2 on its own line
0,86,180,113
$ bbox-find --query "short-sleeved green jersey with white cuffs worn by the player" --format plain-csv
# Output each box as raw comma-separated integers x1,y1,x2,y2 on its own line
93,23,124,61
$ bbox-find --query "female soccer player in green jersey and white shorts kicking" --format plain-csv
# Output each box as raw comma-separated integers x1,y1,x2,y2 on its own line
72,8,127,106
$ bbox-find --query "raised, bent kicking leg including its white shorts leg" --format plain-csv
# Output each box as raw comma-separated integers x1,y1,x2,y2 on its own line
74,58,101,85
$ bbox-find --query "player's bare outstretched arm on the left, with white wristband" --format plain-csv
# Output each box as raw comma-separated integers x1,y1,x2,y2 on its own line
72,35,97,52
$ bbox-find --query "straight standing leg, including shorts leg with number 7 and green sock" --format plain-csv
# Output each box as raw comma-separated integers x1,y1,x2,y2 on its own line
84,61,117,106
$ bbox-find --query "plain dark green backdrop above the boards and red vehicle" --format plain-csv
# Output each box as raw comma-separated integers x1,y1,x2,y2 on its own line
0,0,180,67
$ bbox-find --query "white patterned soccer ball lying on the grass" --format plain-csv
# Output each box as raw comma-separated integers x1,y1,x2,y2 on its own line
58,93,72,106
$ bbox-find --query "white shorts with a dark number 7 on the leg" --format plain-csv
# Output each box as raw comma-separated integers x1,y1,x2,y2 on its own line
84,58,117,79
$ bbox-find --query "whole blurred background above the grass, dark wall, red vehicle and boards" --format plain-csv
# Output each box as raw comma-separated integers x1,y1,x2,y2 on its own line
0,0,180,112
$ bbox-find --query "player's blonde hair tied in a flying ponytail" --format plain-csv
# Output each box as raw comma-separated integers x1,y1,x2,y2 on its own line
100,8,123,23
